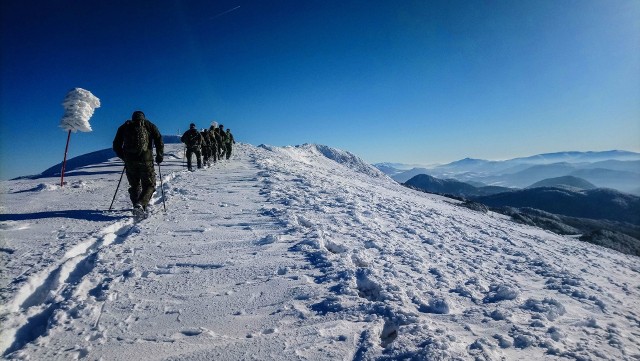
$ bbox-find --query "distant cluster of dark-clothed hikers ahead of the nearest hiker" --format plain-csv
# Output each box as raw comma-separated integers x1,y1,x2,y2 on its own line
180,122,236,171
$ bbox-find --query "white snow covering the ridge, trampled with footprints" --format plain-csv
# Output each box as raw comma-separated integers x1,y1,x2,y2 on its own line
0,144,640,360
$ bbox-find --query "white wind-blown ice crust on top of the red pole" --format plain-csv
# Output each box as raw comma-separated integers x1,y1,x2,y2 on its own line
60,88,100,133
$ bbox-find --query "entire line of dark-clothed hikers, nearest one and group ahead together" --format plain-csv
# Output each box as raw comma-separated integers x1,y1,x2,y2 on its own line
112,110,235,217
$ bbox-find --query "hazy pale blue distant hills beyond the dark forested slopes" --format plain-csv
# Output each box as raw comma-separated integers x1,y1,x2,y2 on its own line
376,150,640,195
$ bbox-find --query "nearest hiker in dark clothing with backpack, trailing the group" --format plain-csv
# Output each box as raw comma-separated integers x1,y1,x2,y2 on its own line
113,110,164,217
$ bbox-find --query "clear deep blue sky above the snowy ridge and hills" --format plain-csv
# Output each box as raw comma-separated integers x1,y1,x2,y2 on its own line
0,0,640,179
